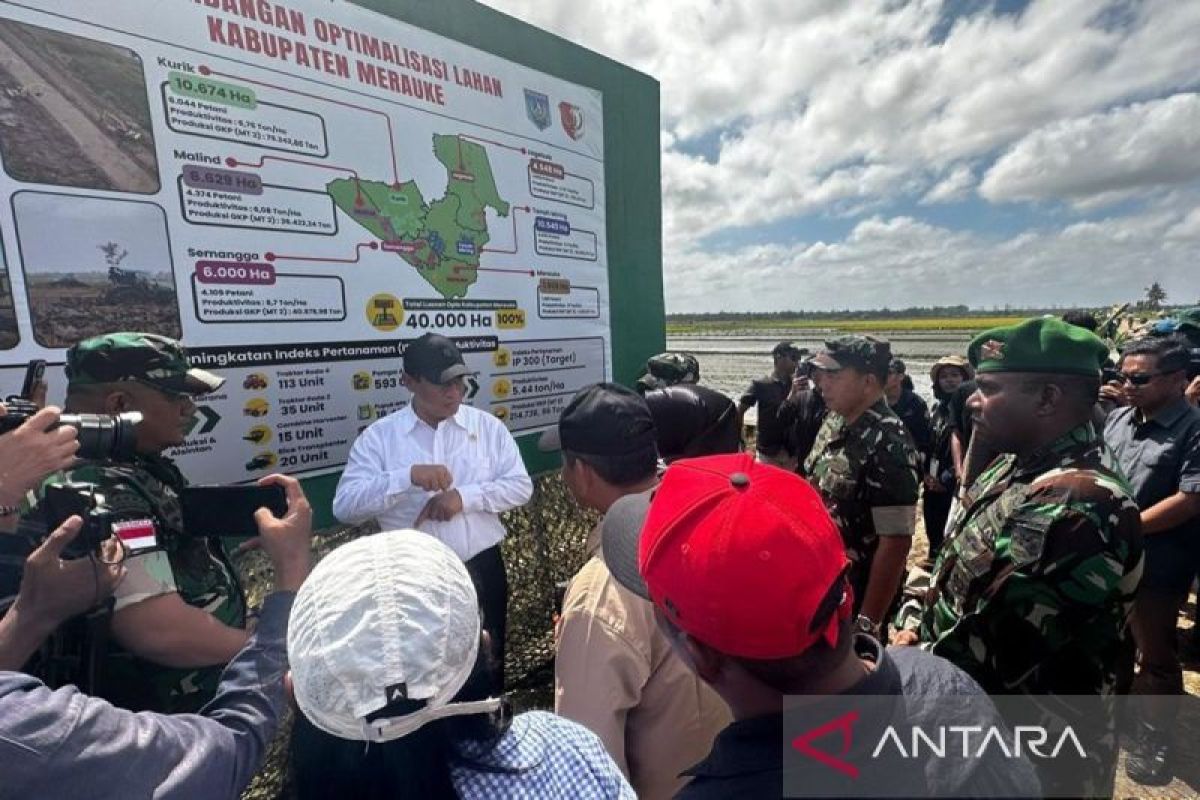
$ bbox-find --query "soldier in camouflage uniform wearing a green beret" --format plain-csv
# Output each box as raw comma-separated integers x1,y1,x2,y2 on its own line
894,318,1142,796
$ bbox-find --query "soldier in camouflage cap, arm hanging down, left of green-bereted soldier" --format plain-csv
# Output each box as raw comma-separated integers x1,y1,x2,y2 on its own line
804,336,918,638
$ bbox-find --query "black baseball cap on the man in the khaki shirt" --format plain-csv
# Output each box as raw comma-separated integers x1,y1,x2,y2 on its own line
538,384,656,456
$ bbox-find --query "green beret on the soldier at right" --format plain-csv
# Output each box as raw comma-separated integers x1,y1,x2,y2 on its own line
967,317,1109,378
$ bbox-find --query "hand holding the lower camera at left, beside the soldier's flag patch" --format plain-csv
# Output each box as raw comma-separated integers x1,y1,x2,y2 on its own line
13,517,125,632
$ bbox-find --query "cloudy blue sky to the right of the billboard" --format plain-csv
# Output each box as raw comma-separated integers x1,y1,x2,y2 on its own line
485,0,1200,312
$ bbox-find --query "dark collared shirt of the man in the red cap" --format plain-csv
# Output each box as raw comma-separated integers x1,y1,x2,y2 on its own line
676,636,1040,800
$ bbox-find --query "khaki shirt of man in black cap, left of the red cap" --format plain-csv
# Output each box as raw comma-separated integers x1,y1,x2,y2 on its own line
554,529,732,800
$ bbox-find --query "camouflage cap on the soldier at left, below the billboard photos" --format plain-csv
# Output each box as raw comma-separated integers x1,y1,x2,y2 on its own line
66,331,224,395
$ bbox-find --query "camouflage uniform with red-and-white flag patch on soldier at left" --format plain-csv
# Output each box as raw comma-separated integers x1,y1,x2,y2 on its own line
20,456,246,712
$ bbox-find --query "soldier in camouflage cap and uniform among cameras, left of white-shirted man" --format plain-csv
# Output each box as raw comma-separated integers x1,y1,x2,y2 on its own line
20,332,248,712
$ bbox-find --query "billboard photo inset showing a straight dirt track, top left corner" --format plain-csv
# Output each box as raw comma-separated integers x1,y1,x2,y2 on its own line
0,19,158,194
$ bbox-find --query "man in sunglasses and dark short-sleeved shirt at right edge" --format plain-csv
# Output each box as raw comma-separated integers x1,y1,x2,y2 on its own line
1104,338,1200,786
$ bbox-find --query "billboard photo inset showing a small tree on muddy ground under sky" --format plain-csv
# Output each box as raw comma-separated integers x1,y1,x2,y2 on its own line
12,192,180,348
